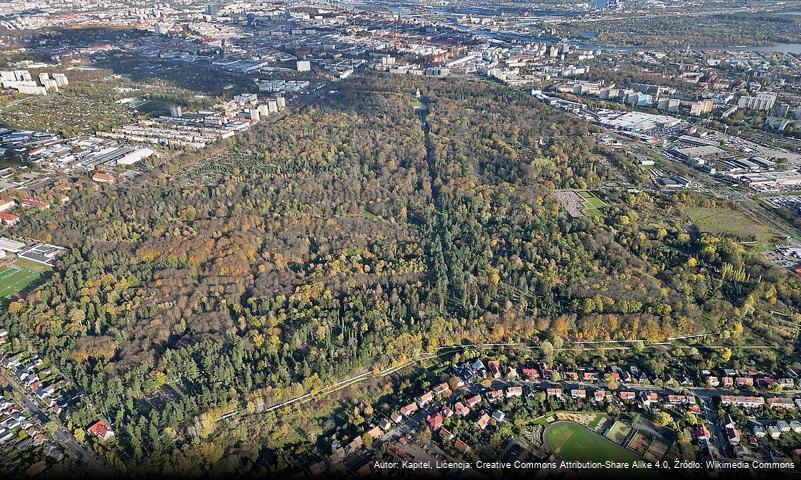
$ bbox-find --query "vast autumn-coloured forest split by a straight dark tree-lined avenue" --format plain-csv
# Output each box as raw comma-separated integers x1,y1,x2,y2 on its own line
0,75,801,473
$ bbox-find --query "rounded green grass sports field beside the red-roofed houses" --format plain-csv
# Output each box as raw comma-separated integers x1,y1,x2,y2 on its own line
544,422,640,462
